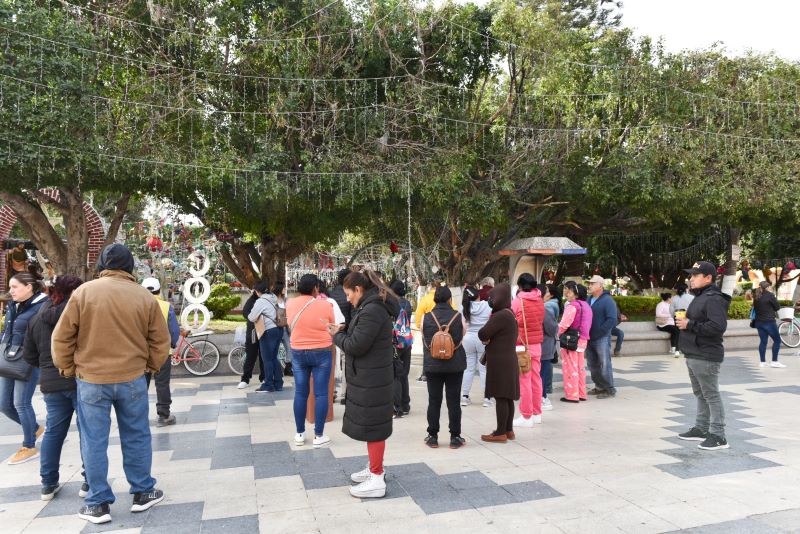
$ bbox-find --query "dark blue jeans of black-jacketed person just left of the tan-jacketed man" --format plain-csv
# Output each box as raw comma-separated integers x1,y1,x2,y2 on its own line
39,389,80,486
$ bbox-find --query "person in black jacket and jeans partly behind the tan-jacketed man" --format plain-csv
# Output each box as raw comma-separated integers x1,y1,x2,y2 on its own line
24,275,89,501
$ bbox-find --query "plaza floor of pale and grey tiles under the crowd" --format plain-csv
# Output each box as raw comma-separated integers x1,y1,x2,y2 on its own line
0,351,800,534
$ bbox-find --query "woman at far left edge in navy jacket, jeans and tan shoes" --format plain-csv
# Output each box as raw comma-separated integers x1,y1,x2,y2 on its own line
0,273,47,465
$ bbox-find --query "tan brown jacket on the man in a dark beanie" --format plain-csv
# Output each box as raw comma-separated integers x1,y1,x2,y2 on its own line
51,272,170,384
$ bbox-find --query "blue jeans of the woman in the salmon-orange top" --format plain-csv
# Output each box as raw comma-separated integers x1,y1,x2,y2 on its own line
292,349,333,436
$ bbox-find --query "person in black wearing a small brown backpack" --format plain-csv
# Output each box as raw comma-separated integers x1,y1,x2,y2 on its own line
422,286,467,449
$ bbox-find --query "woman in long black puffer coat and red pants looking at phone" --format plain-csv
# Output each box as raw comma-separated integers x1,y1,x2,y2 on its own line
328,270,400,498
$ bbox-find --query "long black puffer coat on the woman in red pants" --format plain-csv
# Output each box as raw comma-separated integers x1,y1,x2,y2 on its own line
333,288,400,441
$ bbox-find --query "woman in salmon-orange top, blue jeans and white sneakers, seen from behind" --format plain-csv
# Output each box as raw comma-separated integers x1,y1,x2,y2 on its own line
286,274,334,449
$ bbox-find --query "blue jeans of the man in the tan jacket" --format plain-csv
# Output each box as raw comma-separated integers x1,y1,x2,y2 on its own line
78,375,156,505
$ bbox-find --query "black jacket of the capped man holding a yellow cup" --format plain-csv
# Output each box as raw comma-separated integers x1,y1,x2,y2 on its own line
678,284,731,362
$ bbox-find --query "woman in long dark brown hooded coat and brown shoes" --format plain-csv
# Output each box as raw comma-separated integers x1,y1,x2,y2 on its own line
478,284,519,443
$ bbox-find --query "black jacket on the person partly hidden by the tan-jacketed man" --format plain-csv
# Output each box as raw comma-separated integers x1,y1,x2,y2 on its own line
22,299,76,393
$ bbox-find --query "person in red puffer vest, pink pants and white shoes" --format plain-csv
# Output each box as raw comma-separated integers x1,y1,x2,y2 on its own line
511,273,544,428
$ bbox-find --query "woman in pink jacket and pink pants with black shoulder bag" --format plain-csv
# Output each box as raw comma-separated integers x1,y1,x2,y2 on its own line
558,281,592,403
